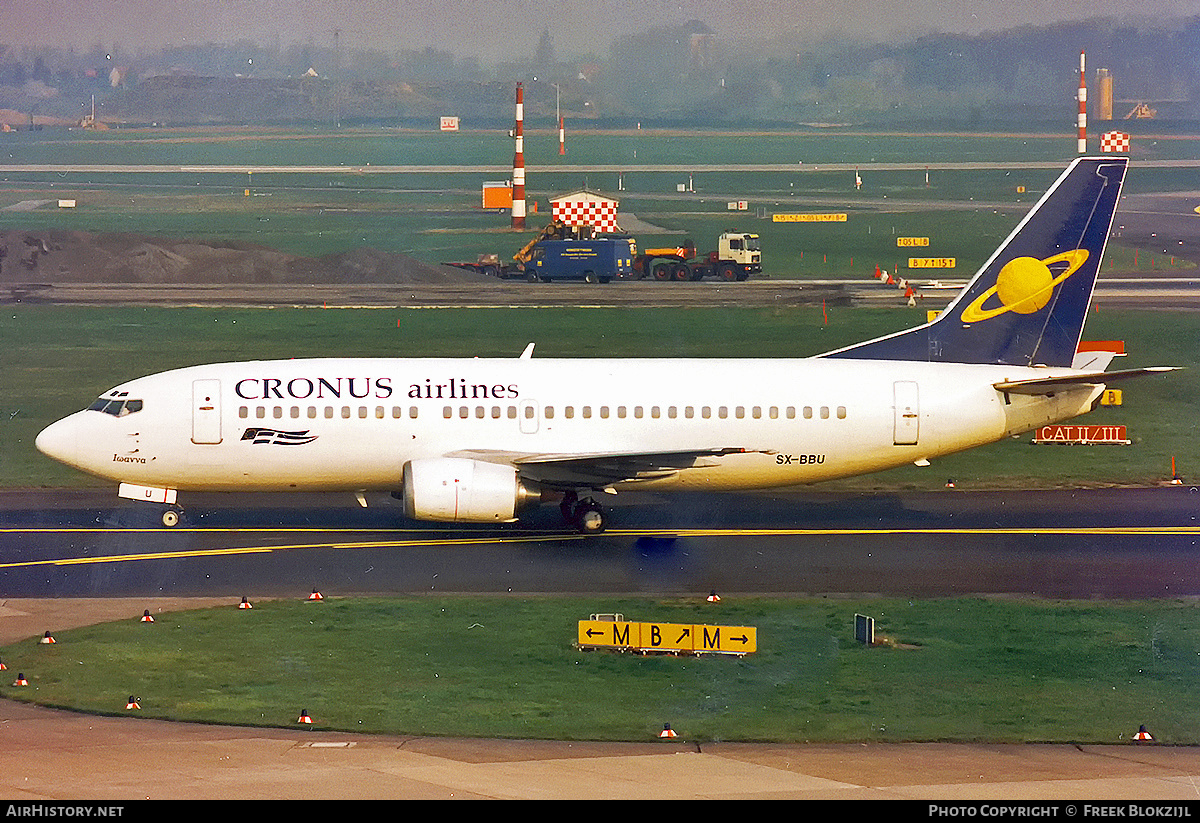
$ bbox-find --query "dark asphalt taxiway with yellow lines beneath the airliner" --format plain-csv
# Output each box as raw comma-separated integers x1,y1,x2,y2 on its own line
0,485,1200,597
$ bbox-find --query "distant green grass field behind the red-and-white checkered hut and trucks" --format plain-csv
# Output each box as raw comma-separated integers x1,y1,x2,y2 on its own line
0,128,1200,272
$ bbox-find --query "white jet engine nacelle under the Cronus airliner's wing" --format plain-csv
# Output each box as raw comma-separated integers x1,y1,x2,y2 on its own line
403,457,540,523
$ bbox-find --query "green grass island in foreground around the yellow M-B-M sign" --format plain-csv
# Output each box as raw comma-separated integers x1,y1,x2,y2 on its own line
0,596,1200,745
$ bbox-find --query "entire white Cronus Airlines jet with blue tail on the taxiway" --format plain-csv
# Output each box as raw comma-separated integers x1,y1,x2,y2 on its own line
37,157,1168,533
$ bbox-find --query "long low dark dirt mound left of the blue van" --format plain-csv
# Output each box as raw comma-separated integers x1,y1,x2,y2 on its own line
0,230,486,284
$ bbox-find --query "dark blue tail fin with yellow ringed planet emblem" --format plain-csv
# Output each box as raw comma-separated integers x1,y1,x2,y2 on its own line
822,157,1128,366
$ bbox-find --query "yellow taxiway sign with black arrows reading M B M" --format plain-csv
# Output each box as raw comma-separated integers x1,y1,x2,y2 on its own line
577,620,758,654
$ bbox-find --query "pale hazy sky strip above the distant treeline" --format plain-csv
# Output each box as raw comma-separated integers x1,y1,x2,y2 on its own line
0,0,1200,62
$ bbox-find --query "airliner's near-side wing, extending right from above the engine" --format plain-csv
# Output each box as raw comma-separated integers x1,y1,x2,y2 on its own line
446,449,749,488
